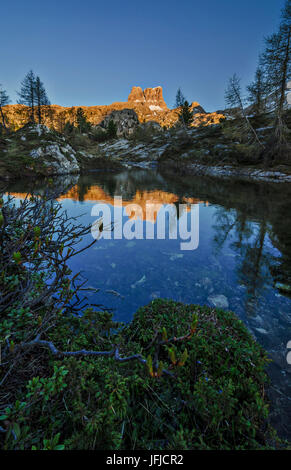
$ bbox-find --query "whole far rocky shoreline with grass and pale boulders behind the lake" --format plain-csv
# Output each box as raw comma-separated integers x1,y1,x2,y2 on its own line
0,119,291,183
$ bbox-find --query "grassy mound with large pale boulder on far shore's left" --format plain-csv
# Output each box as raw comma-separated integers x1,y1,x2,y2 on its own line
0,119,121,179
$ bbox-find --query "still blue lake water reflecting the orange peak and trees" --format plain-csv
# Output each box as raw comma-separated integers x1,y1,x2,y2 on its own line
9,169,291,439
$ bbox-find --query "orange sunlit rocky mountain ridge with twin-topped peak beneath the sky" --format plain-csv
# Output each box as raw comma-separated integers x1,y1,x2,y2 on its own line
3,86,223,131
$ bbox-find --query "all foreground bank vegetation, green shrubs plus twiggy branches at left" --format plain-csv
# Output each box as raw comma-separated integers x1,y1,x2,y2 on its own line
0,193,283,450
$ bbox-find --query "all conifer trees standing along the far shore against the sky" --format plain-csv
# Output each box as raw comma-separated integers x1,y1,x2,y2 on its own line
0,0,291,162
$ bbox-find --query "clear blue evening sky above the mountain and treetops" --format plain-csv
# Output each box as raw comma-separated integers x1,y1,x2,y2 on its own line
0,0,284,111
